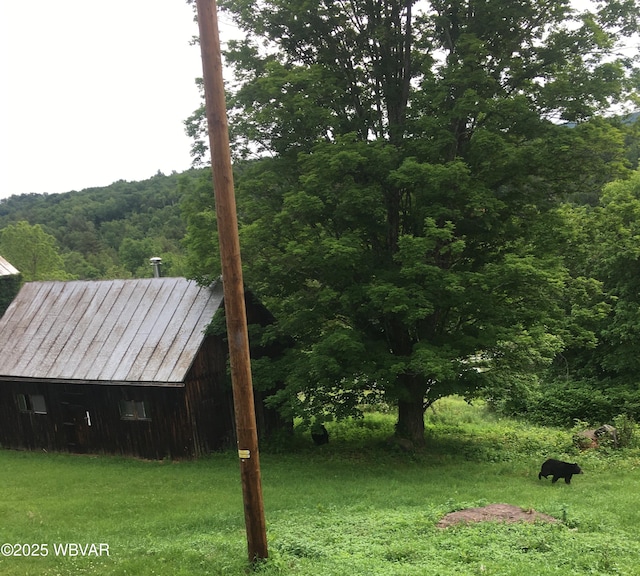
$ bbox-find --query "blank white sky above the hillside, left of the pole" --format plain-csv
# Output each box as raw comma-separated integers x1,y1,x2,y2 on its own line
0,0,224,198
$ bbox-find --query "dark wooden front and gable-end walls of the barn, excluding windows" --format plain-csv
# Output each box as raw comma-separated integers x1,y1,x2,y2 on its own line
0,338,234,459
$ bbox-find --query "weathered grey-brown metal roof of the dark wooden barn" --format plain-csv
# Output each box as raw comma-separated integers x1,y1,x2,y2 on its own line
0,278,222,386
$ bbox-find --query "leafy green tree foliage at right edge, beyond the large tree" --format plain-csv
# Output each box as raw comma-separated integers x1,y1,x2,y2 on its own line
556,171,640,394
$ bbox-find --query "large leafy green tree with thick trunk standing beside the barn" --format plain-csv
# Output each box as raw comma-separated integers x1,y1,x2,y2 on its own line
184,0,636,444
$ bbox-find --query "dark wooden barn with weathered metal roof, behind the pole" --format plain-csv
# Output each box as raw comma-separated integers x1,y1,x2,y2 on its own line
0,278,282,459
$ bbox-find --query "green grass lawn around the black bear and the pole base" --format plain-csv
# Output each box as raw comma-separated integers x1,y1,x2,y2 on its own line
0,399,640,576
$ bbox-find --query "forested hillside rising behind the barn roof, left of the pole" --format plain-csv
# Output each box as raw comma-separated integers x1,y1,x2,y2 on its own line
0,170,202,280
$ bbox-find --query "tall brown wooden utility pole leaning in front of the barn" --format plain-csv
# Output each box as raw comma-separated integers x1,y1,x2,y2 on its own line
196,0,268,563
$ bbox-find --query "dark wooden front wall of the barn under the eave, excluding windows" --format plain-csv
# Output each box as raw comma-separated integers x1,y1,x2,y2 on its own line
0,383,195,458
